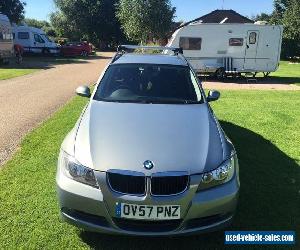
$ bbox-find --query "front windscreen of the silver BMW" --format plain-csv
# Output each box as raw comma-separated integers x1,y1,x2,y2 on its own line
94,64,202,104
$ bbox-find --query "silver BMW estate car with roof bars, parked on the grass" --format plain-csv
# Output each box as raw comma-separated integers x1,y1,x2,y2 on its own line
56,46,240,236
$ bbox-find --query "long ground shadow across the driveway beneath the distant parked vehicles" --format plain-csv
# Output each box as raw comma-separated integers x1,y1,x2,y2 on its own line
1,54,111,69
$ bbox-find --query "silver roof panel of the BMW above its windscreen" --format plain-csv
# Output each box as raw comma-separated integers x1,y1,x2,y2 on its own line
112,53,188,66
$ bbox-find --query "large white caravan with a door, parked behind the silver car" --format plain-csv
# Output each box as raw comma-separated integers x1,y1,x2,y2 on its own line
168,22,283,78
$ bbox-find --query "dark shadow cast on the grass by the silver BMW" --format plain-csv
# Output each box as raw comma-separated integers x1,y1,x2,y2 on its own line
80,122,300,250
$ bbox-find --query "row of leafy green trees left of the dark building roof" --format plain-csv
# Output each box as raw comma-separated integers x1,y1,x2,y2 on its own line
0,0,176,46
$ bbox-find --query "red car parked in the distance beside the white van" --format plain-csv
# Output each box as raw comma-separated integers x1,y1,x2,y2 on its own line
60,42,92,56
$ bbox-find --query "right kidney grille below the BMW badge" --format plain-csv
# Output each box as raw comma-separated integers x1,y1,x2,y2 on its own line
151,175,189,195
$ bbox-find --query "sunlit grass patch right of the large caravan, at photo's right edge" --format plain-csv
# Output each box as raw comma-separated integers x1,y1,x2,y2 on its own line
271,61,300,86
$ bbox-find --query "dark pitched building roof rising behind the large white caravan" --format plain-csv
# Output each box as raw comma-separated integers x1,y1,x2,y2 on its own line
179,10,254,28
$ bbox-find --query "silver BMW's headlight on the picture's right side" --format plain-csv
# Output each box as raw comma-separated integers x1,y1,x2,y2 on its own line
197,155,236,191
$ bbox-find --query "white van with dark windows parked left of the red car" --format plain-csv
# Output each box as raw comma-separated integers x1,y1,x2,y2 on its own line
13,24,59,54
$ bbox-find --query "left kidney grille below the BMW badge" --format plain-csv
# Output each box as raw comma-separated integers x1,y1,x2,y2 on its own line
107,173,146,195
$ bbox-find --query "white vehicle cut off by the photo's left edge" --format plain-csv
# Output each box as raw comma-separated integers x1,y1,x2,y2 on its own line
0,13,14,62
